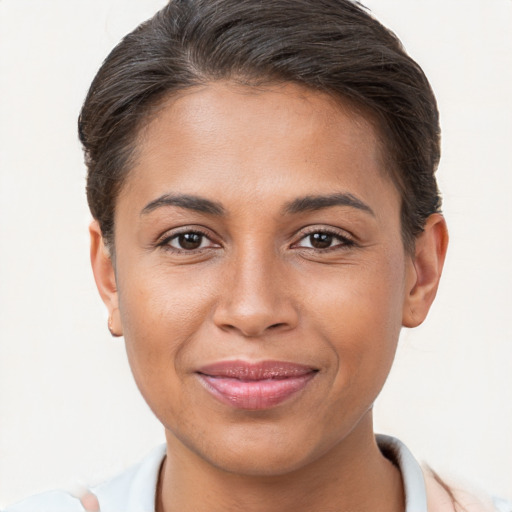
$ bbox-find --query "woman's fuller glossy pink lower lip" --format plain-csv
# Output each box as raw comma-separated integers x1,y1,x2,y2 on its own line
199,372,315,410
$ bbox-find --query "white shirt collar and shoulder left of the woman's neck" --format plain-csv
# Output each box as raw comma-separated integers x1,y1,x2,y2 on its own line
3,445,165,512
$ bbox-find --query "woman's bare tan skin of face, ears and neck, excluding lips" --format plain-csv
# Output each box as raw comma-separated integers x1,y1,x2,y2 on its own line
90,83,447,512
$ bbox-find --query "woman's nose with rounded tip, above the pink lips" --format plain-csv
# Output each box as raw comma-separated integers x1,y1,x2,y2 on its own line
213,246,299,338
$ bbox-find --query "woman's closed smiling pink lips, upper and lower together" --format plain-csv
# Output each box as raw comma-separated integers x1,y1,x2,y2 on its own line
197,360,318,410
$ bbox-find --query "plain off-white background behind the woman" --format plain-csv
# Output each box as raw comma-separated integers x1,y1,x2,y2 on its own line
0,0,512,506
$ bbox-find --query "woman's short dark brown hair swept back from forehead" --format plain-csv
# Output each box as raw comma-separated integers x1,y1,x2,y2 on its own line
79,0,441,250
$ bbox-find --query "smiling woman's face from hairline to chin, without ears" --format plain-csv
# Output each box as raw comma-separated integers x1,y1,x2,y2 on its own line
97,83,415,474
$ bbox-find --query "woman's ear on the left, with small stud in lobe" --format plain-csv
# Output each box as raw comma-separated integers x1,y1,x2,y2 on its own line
89,220,123,336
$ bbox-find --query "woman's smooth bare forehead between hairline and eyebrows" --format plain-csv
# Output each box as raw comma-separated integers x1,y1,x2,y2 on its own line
121,82,400,212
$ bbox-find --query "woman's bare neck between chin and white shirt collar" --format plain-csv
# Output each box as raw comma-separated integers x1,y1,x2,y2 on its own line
157,413,404,512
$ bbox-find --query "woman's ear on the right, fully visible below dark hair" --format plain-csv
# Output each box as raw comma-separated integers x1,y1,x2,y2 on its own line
402,213,448,327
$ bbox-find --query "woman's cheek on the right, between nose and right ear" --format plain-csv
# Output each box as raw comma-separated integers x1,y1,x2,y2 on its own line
305,254,404,395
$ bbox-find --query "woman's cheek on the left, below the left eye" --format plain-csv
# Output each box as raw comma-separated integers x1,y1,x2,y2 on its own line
115,265,219,388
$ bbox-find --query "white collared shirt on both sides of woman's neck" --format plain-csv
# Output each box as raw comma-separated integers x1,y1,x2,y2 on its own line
4,435,512,512
